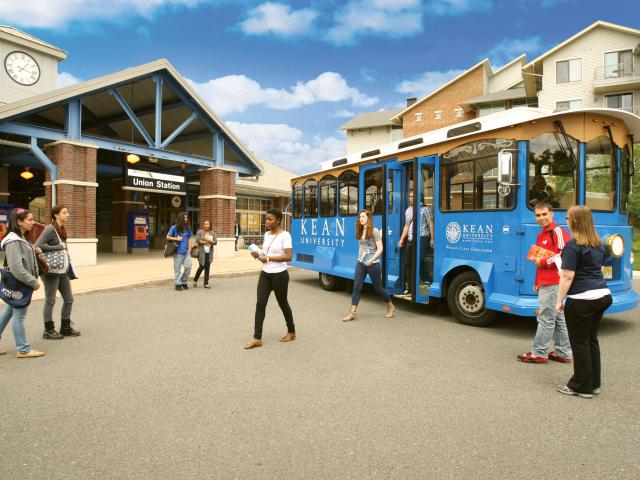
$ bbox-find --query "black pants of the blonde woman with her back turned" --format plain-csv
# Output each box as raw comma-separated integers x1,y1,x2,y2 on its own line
564,295,613,393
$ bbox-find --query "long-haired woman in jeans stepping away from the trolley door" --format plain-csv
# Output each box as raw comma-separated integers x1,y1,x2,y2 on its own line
342,210,395,322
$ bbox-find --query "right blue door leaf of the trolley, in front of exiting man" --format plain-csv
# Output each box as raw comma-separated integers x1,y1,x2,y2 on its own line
413,157,435,303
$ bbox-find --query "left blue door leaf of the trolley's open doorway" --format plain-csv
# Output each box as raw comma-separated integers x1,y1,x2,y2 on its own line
384,163,405,295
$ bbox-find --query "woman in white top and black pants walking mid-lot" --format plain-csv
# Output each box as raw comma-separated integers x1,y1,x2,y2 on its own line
244,208,296,350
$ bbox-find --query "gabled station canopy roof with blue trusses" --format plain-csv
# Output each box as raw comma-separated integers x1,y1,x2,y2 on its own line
0,60,262,176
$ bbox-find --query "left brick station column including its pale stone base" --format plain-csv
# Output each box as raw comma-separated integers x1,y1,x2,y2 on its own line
44,140,98,266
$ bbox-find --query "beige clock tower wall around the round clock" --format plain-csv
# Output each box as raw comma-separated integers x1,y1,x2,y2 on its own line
0,38,58,104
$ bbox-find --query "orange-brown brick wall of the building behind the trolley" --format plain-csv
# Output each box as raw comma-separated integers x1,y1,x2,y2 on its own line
402,65,484,137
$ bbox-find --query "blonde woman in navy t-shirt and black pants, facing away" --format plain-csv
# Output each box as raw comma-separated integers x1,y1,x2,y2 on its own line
556,205,612,398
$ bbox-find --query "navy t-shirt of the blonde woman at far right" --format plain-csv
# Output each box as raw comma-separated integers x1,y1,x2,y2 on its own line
561,238,607,295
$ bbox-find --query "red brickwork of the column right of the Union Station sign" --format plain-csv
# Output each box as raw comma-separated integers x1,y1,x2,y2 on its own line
200,167,236,237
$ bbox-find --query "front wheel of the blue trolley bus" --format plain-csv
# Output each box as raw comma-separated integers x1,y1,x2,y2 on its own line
447,271,496,327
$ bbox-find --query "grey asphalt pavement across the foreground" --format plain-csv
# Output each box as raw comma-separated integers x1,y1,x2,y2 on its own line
0,271,640,480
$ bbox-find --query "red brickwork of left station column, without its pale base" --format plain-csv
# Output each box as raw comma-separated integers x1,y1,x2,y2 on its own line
45,143,97,238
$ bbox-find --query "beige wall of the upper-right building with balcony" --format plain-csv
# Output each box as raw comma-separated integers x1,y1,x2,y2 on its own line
538,27,640,109
